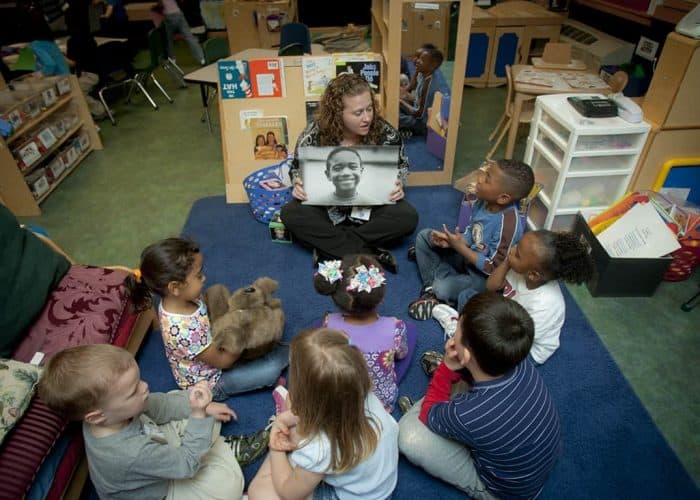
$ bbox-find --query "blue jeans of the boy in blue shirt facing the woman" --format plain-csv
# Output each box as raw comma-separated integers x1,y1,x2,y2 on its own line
416,229,487,306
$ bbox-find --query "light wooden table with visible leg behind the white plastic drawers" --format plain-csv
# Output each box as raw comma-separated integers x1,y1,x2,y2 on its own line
505,64,611,159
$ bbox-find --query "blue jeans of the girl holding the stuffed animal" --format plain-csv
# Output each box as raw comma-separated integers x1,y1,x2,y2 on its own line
212,344,289,401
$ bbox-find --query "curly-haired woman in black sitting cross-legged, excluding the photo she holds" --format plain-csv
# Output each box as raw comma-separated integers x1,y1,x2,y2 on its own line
281,74,418,272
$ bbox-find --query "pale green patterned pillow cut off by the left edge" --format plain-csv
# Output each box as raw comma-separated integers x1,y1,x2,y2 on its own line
0,359,41,443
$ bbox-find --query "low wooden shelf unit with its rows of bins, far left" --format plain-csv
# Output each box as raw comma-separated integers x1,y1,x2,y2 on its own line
0,75,102,216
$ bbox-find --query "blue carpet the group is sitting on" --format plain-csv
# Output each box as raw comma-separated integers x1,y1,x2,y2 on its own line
134,186,700,500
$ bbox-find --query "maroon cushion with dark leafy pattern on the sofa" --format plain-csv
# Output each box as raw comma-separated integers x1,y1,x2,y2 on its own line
12,266,128,361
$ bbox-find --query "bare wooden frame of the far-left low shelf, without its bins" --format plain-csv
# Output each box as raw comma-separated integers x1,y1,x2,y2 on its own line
0,75,102,216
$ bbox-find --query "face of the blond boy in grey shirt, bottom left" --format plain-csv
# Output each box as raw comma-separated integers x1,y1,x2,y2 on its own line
100,362,149,425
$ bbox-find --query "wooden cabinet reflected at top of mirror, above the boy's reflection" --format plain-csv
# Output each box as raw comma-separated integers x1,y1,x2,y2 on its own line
401,2,450,57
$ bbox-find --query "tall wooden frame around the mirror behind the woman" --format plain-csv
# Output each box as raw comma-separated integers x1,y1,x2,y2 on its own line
372,0,474,186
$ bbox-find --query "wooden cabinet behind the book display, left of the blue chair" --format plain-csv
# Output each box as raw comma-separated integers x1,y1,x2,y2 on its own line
224,0,297,54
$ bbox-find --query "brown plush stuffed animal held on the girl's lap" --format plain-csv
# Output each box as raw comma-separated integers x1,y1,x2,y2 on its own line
204,277,284,360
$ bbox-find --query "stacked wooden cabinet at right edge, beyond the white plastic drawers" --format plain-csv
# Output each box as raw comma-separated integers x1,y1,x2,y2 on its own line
632,33,700,189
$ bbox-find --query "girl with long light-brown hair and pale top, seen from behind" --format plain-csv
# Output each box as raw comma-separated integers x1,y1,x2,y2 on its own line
248,328,399,500
